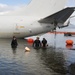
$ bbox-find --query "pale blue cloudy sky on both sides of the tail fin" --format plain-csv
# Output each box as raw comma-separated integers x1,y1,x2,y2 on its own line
0,0,75,23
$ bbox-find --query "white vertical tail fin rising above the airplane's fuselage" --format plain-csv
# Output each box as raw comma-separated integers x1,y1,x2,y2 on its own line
5,0,66,18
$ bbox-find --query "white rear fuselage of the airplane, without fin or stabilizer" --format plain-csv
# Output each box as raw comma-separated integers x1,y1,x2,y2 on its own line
0,16,52,38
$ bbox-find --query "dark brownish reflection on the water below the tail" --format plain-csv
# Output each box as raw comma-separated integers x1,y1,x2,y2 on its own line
35,47,67,74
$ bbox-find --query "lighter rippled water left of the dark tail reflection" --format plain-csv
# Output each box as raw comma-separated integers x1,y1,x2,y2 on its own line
0,39,58,75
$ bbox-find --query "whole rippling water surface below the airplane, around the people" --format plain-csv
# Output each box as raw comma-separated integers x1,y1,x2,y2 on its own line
0,34,75,75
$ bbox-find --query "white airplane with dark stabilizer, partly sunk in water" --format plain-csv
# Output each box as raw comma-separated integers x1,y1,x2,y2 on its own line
0,0,75,38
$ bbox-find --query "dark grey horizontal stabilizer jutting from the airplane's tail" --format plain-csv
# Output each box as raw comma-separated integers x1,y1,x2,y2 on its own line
39,7,75,24
